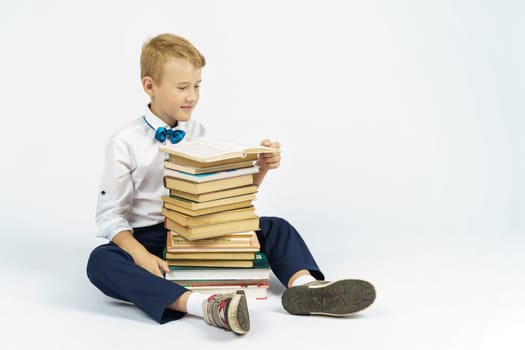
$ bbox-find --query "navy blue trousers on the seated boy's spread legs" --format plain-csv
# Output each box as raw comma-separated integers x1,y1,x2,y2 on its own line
87,217,324,323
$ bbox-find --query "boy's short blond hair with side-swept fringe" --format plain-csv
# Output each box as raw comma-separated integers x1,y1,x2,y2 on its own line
140,33,206,83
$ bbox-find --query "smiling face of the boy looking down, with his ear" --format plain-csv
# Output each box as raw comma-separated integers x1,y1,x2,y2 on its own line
142,58,201,126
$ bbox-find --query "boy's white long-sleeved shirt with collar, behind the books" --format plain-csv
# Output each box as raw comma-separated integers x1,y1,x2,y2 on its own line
96,108,205,240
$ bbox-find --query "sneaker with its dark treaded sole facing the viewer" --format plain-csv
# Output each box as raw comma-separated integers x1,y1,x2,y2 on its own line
281,279,376,316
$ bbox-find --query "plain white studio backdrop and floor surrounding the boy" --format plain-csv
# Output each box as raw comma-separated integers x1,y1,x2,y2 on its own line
0,0,525,349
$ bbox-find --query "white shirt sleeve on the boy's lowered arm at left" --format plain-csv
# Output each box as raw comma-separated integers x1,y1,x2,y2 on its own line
96,137,136,240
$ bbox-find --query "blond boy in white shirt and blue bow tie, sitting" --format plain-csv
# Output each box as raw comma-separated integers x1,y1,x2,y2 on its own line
87,34,375,334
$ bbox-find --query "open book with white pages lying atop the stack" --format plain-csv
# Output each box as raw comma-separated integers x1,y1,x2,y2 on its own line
160,137,280,163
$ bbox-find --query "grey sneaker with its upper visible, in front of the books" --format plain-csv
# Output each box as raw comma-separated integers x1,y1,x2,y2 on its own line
203,290,250,335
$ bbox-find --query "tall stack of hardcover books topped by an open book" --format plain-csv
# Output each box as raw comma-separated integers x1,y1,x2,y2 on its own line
160,138,278,298
